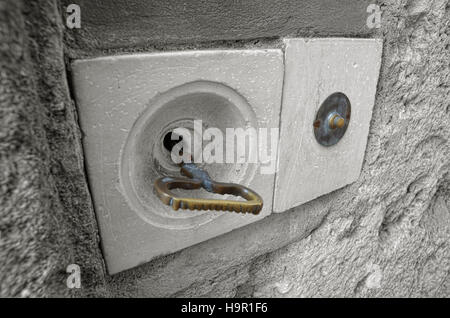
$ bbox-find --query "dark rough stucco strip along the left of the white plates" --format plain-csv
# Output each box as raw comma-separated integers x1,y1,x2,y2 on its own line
0,0,103,297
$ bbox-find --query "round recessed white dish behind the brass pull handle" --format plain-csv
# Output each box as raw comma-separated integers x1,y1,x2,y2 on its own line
120,82,257,229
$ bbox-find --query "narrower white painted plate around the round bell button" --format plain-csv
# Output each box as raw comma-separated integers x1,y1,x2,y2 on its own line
274,38,382,212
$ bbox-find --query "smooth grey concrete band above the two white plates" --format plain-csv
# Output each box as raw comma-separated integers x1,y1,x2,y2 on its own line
61,0,371,54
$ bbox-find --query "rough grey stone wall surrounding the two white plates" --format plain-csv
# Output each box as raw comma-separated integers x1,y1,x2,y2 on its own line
0,0,450,297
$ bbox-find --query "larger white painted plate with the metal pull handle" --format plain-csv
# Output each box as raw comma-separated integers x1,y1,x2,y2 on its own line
72,49,283,274
